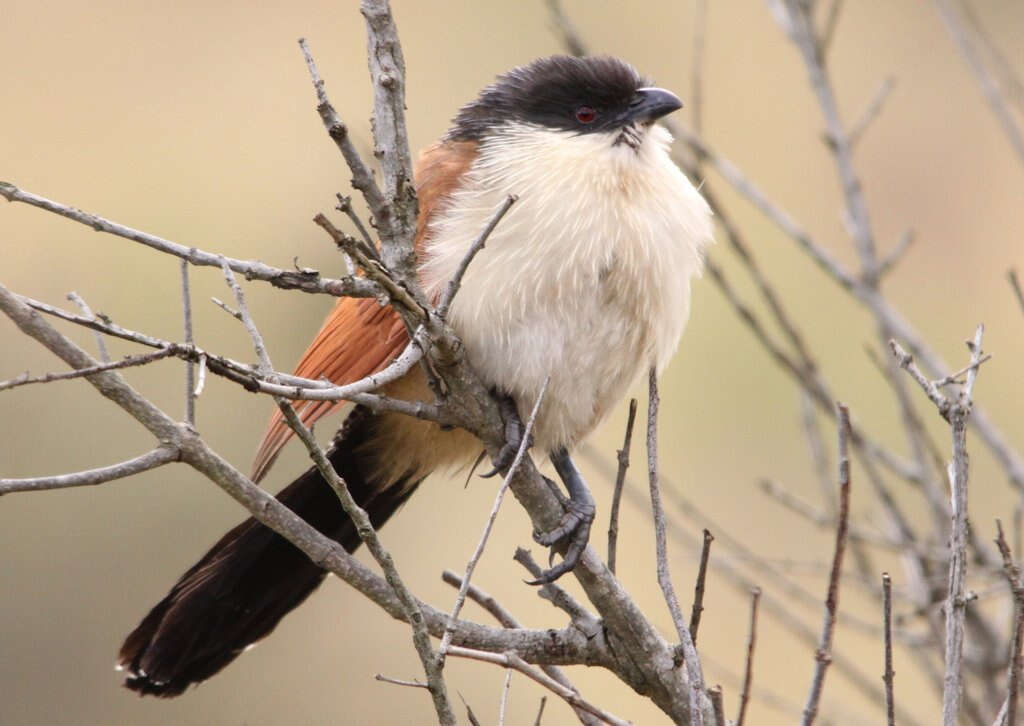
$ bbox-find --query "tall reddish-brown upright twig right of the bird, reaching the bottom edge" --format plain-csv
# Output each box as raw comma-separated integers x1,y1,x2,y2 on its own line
801,403,850,726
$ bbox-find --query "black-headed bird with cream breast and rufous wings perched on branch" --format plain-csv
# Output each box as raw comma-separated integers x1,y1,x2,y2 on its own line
118,55,713,697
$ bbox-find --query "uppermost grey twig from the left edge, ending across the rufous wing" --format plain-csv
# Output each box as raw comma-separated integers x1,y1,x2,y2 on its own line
0,181,381,297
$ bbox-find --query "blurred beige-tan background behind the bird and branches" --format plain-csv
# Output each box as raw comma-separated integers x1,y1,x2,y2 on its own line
0,0,1024,725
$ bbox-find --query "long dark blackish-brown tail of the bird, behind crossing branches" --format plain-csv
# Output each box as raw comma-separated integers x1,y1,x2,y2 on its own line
119,409,419,697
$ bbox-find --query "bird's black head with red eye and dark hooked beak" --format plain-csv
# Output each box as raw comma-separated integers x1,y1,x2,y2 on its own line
447,55,683,151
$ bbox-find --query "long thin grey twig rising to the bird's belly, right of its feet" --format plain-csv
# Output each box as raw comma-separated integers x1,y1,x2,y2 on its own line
647,368,707,726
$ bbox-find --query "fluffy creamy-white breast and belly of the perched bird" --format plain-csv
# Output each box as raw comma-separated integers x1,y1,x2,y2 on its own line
423,125,712,451
